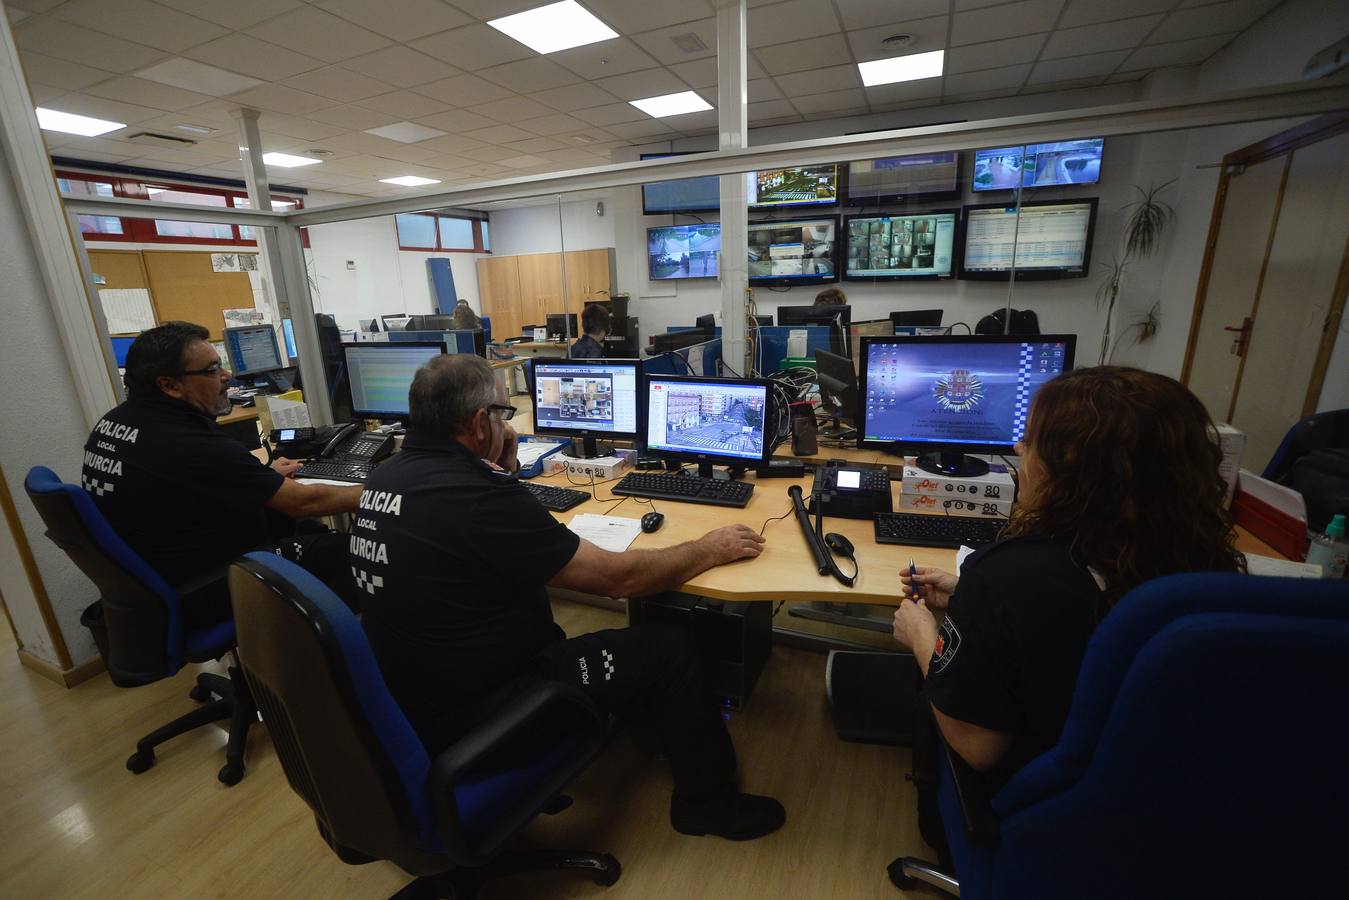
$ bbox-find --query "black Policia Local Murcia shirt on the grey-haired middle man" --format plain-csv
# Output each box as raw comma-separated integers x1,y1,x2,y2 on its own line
351,432,580,750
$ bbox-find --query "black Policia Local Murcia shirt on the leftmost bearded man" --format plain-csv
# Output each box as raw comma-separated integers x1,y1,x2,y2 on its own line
80,397,285,584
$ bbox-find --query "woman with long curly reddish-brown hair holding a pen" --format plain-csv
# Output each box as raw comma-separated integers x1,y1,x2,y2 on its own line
893,366,1245,791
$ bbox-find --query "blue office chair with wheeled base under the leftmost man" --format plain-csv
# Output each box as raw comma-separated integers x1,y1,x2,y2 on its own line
23,466,258,785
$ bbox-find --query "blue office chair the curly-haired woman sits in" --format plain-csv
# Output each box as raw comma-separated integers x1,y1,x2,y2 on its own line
890,573,1349,900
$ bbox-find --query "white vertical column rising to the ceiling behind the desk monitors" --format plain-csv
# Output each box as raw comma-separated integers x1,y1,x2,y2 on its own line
716,0,749,375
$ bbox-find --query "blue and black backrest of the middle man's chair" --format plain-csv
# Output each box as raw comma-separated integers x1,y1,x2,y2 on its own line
229,552,448,874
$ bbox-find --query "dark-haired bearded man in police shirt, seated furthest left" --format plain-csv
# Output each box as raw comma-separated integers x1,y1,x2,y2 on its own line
80,322,360,625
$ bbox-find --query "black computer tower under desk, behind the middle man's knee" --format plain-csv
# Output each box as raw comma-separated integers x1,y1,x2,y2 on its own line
627,591,773,710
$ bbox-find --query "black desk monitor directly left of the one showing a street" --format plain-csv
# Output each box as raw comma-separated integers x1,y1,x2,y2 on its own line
533,356,642,459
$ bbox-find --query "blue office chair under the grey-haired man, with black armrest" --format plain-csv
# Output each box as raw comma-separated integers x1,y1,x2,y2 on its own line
229,553,621,897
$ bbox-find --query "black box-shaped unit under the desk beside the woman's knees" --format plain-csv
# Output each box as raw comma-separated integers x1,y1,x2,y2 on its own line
824,650,919,745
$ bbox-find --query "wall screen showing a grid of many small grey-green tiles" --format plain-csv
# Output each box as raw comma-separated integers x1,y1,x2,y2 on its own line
843,209,959,281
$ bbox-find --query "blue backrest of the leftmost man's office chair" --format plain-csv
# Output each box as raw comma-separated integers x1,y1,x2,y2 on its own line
23,466,183,687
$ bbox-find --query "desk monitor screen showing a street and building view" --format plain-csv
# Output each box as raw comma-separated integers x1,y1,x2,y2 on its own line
646,378,768,459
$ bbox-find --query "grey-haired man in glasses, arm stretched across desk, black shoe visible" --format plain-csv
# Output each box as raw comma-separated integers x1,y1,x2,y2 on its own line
351,354,786,839
